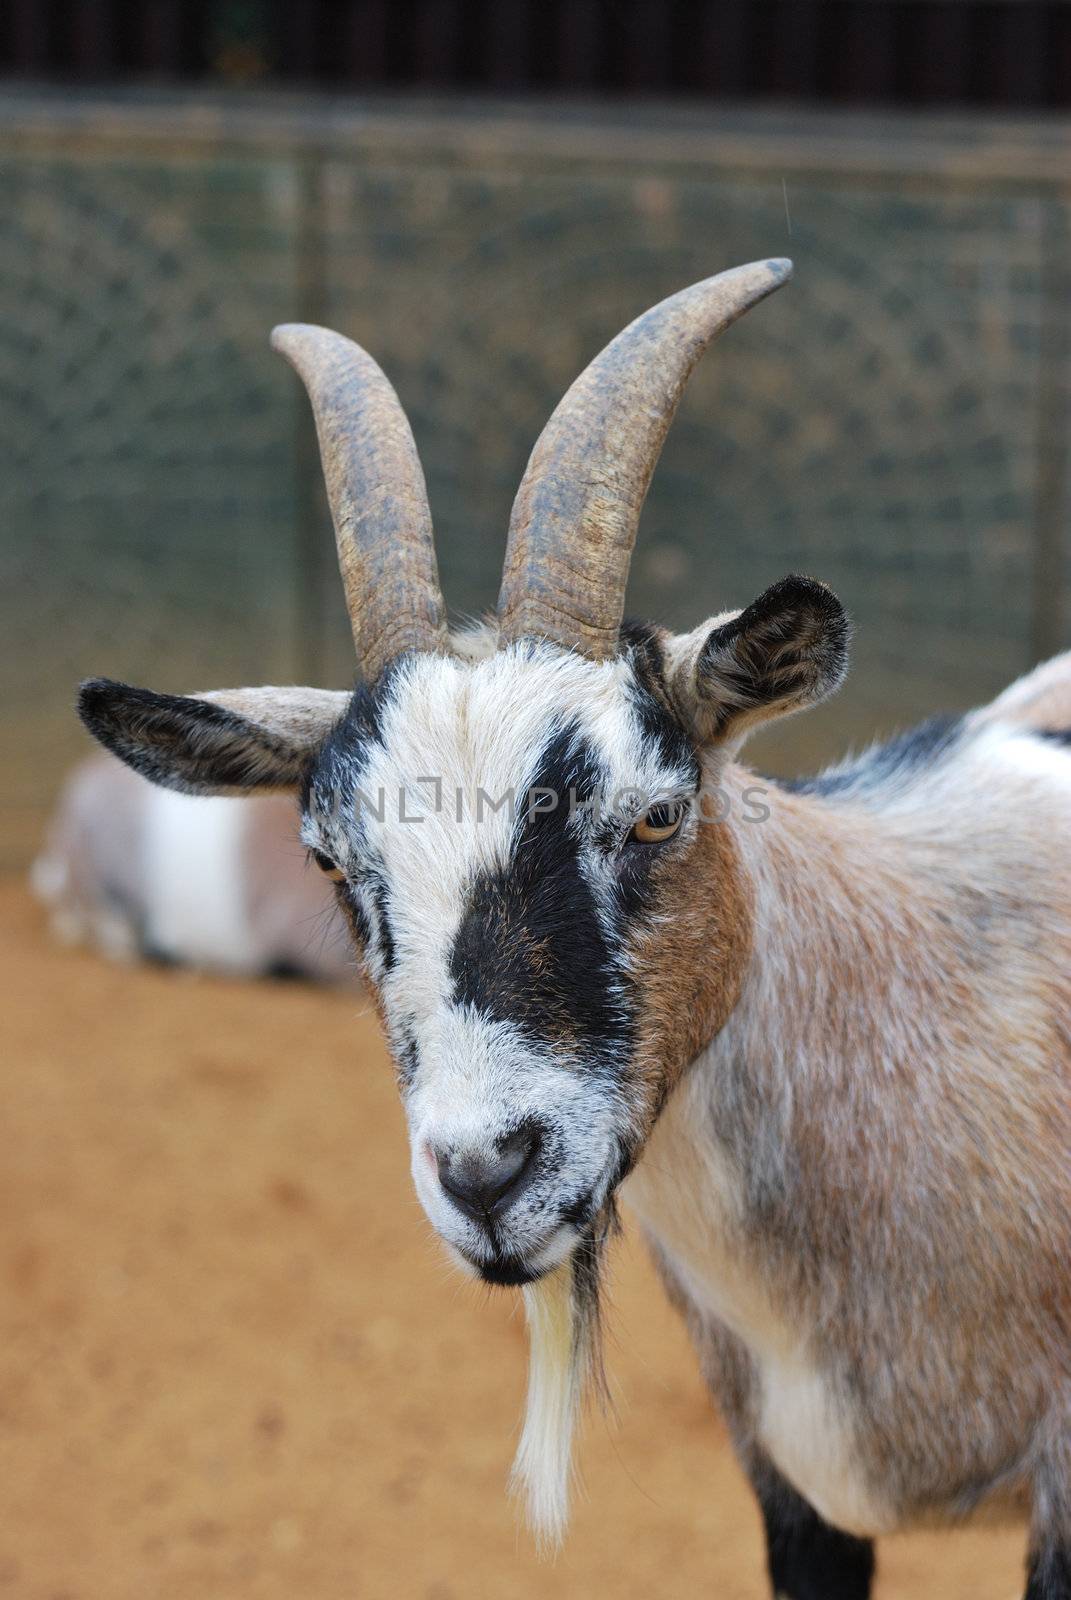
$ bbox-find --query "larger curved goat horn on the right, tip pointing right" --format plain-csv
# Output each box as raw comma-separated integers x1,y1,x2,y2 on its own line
498,261,792,661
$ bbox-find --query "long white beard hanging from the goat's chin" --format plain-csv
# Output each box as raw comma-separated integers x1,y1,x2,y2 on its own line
511,1198,618,1552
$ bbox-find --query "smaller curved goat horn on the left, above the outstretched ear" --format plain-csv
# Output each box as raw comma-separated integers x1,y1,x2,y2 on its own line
272,322,447,683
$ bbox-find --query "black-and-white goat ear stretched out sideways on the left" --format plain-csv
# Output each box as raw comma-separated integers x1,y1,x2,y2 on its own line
78,678,349,795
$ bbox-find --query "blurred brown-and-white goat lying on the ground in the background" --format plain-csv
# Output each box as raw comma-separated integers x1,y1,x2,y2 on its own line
30,752,355,982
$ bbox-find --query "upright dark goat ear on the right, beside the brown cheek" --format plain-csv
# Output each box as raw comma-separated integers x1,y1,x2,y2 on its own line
674,578,852,747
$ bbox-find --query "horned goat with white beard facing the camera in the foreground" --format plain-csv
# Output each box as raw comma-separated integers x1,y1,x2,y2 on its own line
80,261,1071,1600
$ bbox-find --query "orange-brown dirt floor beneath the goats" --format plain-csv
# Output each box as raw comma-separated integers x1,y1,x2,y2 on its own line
0,885,1021,1600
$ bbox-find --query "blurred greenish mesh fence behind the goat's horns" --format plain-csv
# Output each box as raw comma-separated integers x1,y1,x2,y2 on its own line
0,94,1071,862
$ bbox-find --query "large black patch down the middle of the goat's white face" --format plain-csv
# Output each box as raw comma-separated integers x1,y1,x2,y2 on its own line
450,725,631,1062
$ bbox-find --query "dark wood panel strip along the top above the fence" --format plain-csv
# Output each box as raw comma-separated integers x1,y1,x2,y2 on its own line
0,0,1071,107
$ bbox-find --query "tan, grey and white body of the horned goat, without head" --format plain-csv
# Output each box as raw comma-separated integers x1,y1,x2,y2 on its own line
624,656,1071,1534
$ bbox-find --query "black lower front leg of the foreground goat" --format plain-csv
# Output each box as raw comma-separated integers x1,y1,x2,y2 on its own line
754,1466,874,1600
